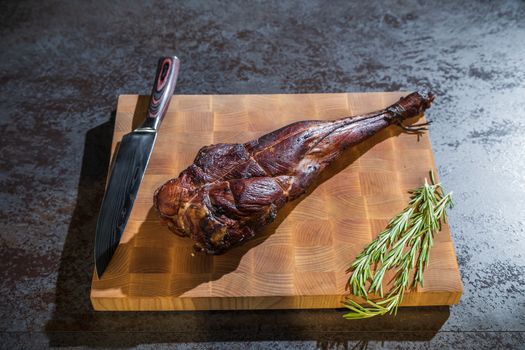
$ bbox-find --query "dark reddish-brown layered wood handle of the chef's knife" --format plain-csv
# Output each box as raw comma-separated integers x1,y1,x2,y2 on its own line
139,56,180,131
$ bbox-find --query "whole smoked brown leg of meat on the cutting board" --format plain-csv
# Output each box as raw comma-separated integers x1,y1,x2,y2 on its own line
154,92,433,254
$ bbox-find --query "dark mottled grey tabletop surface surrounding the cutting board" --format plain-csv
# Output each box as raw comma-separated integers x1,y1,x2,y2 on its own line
0,0,525,349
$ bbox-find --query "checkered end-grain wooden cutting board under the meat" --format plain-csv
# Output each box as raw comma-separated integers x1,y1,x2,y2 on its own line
91,92,462,310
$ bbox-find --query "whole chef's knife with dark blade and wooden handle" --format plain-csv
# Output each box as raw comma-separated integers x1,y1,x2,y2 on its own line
95,56,179,278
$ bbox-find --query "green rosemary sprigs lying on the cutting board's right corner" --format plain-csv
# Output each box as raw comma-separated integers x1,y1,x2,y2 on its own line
344,172,452,319
